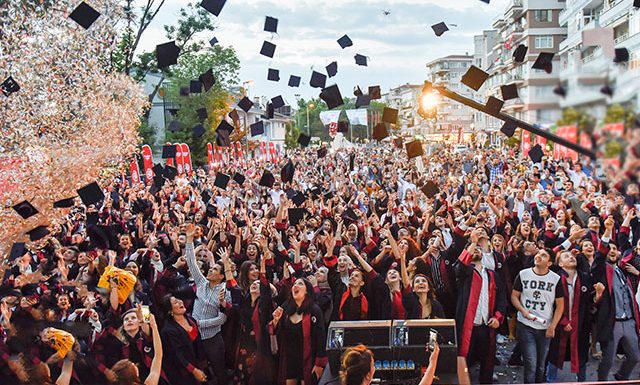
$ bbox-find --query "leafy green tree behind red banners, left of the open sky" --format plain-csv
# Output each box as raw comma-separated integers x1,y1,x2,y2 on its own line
165,46,240,165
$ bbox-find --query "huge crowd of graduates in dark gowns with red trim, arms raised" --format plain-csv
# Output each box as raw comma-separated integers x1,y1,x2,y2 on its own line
0,137,640,385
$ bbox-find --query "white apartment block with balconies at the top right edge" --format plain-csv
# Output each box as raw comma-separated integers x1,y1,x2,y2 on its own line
559,0,640,119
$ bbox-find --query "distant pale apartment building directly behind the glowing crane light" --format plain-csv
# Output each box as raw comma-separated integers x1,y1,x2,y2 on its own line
426,54,475,134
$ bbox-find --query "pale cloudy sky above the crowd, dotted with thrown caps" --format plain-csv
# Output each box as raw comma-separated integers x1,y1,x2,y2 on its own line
139,0,508,105
